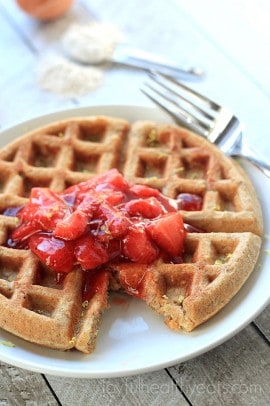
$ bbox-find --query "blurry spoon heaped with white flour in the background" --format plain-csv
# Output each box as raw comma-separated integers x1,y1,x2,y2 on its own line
62,22,204,80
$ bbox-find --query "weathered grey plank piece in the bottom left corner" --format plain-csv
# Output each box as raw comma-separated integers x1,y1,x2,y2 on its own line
0,362,59,406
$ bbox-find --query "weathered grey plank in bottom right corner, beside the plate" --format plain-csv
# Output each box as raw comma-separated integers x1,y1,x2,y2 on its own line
169,326,270,406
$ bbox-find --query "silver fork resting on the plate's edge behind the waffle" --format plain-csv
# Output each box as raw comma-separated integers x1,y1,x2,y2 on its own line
141,72,270,177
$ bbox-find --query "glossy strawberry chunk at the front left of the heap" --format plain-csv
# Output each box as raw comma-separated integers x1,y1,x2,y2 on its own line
29,233,74,273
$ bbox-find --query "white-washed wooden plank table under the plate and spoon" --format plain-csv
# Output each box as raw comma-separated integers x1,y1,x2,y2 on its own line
0,0,270,406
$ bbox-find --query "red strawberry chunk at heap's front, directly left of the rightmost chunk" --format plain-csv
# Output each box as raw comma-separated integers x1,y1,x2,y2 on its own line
122,226,159,264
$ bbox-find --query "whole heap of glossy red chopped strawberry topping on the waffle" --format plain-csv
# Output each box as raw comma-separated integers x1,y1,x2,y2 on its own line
7,169,199,273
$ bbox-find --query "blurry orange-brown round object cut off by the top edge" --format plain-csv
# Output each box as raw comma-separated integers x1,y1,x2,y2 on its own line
17,0,73,20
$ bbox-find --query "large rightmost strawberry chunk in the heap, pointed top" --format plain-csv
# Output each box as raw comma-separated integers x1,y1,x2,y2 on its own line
146,212,185,256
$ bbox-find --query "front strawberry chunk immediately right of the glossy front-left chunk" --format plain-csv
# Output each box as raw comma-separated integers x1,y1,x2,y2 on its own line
74,235,109,270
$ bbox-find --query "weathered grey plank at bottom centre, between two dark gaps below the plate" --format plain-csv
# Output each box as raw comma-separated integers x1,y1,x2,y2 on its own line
47,370,188,406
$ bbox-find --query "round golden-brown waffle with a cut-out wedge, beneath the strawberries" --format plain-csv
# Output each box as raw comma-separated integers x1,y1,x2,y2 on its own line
0,116,262,353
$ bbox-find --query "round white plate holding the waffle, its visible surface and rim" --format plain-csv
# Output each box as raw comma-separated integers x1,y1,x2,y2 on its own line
0,106,270,378
